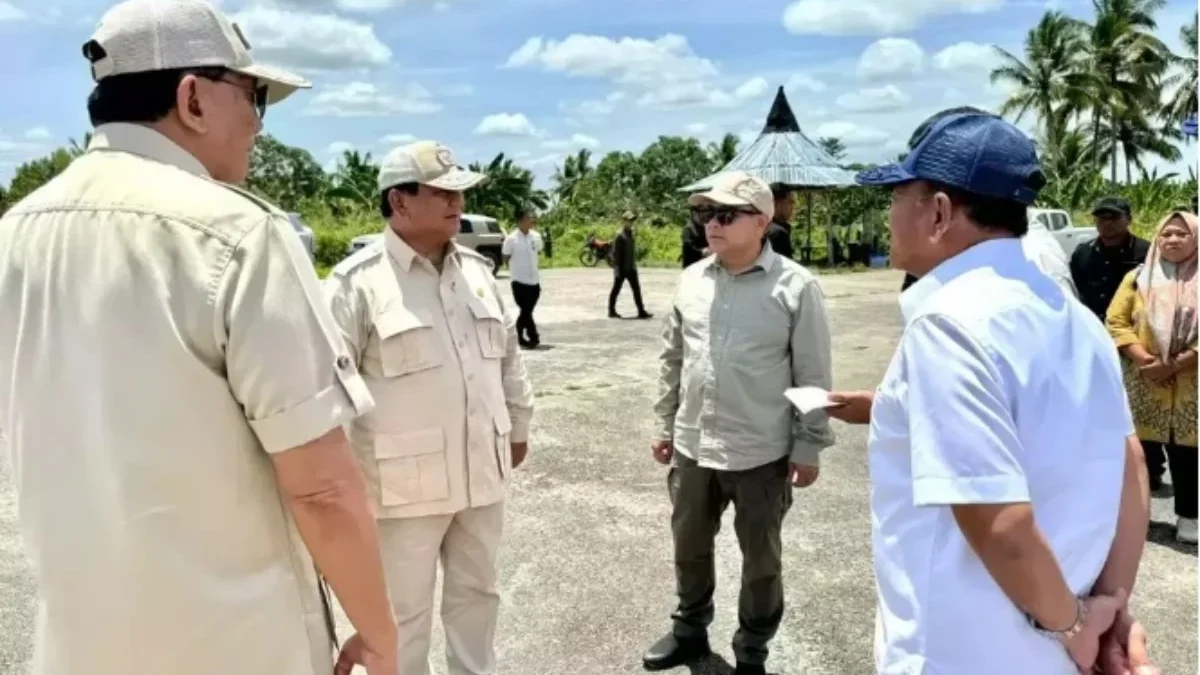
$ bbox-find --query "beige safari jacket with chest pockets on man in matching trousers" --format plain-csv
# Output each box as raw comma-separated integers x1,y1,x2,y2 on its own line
325,227,533,518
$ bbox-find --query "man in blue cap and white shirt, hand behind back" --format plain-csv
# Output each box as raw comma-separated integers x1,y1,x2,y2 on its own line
829,112,1148,675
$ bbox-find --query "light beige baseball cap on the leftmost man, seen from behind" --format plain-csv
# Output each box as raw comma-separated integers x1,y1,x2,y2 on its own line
83,0,312,103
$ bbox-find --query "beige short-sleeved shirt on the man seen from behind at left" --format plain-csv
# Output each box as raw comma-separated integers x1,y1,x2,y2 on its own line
0,124,371,675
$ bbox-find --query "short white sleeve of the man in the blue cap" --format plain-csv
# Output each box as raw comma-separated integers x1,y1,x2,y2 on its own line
900,315,1030,506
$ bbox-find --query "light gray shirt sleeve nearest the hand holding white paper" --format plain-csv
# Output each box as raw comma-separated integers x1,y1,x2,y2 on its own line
791,279,834,466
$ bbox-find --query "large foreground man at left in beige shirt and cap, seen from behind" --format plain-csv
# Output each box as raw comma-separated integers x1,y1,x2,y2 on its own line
0,0,397,675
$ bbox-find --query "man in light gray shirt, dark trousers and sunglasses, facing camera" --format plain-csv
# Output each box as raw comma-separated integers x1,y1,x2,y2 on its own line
643,172,833,675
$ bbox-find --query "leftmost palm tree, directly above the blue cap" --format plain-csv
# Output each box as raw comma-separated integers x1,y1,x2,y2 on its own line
991,11,1084,159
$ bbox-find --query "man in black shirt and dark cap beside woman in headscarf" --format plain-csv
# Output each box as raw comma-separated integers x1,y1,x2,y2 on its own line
1070,197,1166,482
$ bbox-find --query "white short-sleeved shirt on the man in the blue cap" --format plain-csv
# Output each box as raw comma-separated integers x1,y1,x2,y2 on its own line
868,239,1133,675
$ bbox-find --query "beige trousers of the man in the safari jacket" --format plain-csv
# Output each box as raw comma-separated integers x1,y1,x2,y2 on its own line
378,502,504,675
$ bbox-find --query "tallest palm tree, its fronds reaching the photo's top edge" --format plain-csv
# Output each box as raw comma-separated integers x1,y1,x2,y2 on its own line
1081,0,1170,183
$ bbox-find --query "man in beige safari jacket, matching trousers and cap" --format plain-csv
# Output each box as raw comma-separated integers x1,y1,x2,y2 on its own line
325,141,533,675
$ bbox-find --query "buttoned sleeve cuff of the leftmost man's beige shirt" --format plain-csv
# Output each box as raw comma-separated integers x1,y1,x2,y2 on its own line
255,375,374,454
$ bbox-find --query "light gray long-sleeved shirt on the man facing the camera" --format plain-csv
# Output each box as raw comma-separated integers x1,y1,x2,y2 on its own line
654,246,834,471
